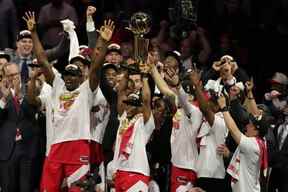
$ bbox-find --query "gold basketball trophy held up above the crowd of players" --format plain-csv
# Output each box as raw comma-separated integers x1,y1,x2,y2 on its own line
128,12,152,64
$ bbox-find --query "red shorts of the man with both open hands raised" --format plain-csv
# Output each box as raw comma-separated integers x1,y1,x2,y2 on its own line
40,140,90,192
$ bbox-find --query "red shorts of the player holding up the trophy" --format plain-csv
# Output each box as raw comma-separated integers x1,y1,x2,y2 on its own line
115,171,150,192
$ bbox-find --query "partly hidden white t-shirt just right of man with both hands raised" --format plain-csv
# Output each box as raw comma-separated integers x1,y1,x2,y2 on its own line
90,88,110,144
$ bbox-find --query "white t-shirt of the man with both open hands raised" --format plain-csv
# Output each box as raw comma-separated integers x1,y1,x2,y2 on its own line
39,75,93,154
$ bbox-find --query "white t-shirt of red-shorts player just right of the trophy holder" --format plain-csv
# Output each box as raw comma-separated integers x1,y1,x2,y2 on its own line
171,89,203,171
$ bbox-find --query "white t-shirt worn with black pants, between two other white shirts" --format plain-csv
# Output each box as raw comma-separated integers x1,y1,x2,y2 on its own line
197,113,228,179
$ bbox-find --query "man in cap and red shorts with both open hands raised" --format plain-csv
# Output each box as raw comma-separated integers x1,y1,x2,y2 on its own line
24,12,114,191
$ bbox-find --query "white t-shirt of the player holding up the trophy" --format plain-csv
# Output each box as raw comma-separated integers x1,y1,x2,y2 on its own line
112,112,155,176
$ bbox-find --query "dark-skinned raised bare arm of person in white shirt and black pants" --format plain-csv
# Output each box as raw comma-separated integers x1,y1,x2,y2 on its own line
190,70,215,127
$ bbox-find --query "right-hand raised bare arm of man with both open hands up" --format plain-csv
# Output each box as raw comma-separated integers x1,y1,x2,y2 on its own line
89,20,115,91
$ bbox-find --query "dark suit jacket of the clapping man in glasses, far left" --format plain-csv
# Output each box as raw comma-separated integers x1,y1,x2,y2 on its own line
0,96,39,160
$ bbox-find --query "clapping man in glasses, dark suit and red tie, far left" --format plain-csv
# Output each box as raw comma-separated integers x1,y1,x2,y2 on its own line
0,64,39,192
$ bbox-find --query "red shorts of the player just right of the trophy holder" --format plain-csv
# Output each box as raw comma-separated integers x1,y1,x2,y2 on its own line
170,165,197,192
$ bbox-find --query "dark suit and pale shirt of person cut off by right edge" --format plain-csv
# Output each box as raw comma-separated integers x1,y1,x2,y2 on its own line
267,113,288,192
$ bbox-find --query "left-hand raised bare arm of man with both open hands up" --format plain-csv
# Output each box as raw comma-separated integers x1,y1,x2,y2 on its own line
23,11,55,85
